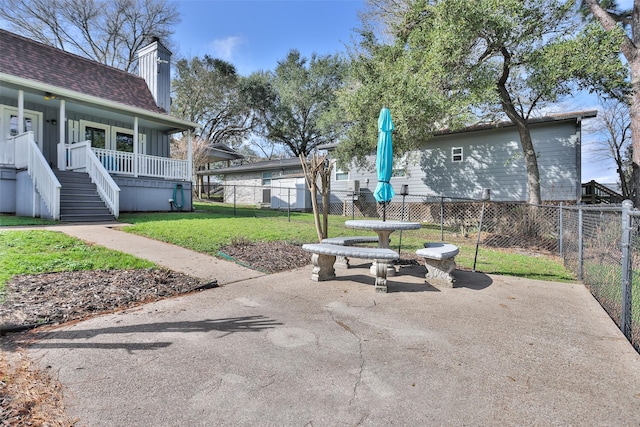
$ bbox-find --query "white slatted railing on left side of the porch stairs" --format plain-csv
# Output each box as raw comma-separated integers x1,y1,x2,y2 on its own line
14,132,62,220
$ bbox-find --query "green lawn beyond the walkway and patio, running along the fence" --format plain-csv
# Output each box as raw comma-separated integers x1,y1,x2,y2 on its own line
120,203,575,282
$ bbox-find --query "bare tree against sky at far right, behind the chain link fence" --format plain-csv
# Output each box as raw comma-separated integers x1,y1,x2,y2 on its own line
592,99,631,198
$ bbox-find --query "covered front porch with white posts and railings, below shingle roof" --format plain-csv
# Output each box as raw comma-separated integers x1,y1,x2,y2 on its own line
0,82,197,220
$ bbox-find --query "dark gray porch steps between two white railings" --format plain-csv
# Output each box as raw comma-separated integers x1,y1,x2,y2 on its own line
53,170,115,222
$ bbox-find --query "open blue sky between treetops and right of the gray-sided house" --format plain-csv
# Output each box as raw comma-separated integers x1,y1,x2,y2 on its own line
173,0,625,183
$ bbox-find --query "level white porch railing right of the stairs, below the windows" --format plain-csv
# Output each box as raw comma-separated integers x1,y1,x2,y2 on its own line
93,148,191,181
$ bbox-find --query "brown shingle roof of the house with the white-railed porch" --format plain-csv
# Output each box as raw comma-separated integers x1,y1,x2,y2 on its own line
0,29,164,113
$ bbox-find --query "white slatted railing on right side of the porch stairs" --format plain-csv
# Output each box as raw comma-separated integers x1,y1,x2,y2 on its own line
58,141,120,218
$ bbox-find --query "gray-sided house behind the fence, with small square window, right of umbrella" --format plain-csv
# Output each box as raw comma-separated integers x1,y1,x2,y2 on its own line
324,111,596,202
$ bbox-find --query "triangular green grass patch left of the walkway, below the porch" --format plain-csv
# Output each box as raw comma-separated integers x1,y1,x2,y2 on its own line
0,229,155,291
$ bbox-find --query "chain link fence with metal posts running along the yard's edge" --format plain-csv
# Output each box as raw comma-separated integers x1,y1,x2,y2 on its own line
194,185,640,351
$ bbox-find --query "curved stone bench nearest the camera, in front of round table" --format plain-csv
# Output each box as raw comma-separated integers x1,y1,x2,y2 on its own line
302,243,399,292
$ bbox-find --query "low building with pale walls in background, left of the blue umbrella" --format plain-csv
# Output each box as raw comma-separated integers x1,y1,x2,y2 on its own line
208,157,311,210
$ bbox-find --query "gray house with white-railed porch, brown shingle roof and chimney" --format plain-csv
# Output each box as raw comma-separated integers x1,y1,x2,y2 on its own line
0,30,198,221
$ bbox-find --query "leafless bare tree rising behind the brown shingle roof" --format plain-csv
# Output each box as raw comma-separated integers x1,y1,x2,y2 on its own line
0,0,180,72
